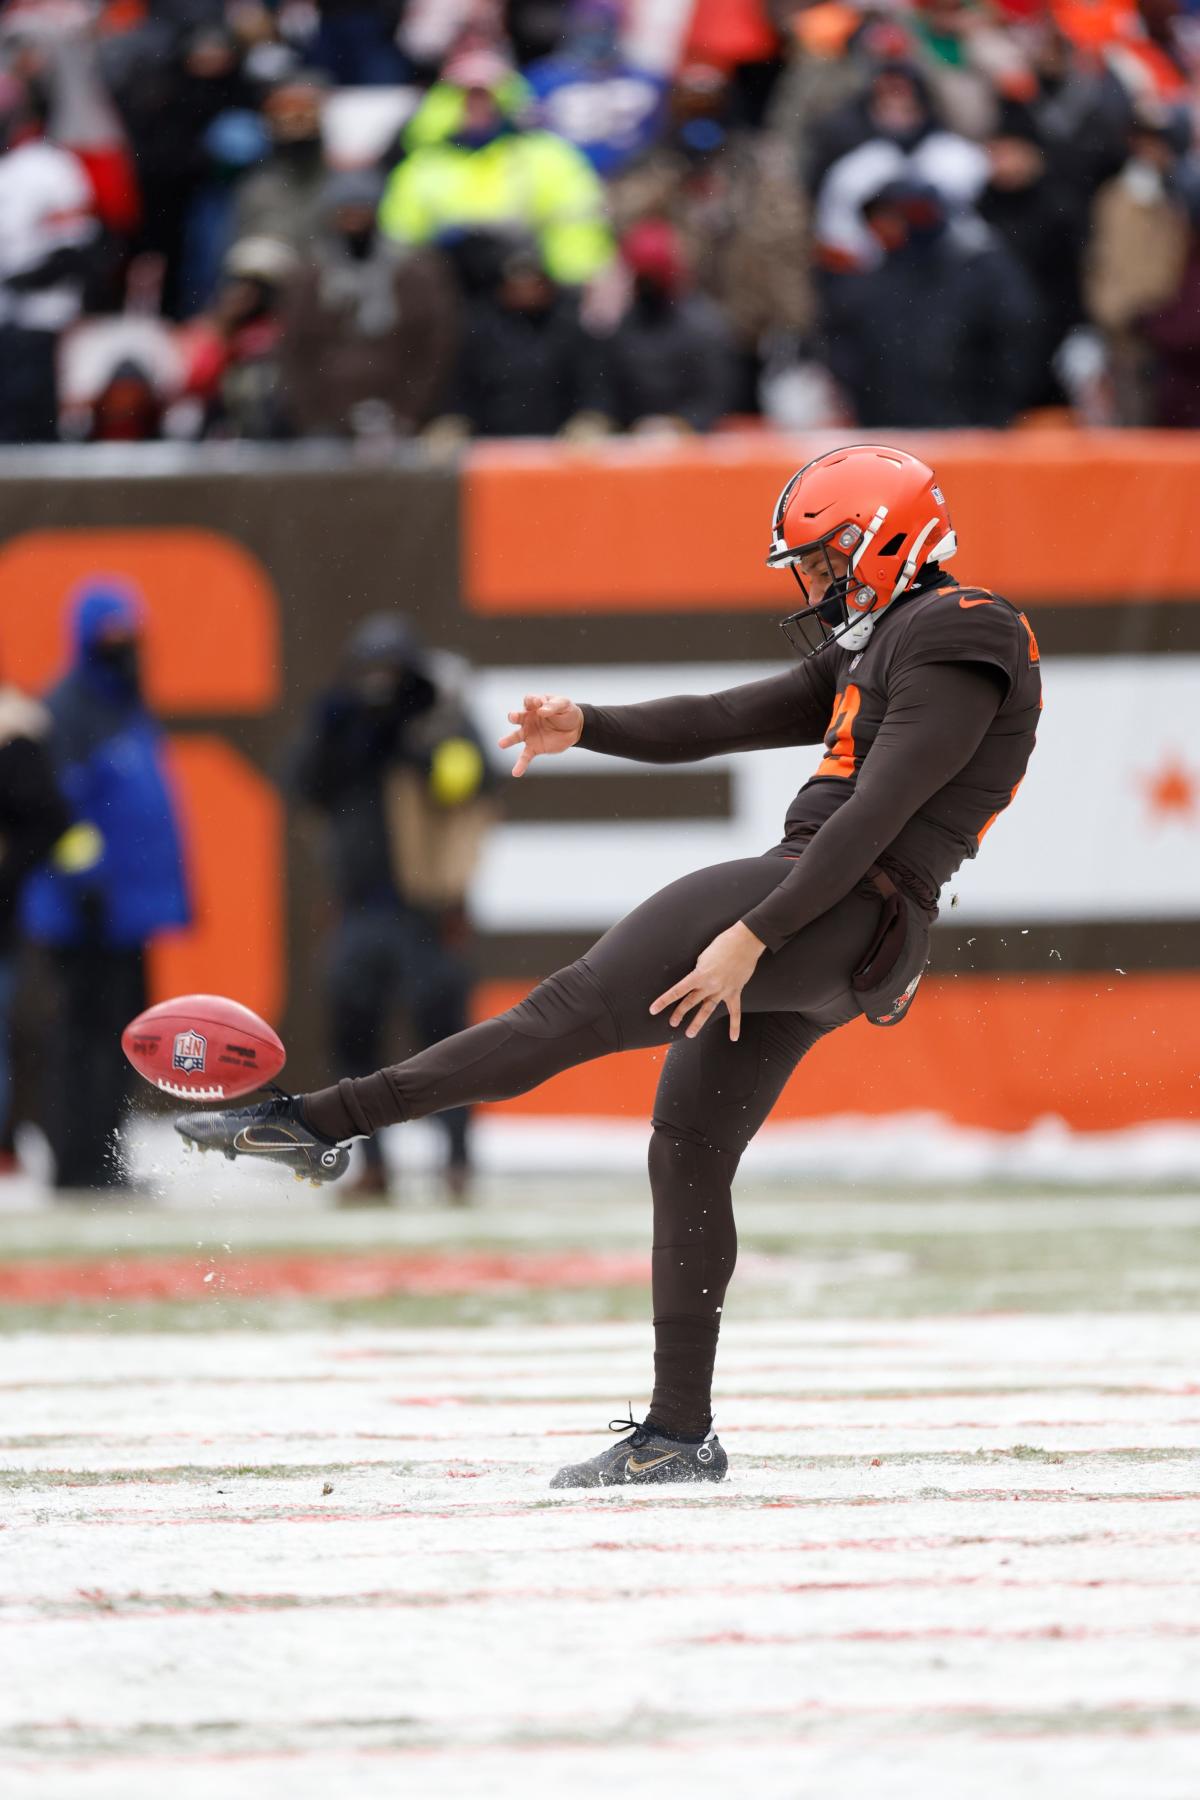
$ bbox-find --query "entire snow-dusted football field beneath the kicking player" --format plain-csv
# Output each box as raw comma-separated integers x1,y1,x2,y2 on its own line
0,1170,1200,1800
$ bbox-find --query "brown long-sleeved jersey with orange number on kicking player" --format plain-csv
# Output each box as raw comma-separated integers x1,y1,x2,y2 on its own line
579,576,1042,950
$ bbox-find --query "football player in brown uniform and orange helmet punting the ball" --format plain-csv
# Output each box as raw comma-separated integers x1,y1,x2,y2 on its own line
176,445,1042,1487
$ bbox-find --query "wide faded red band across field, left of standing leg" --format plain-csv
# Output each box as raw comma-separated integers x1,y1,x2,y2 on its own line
0,1251,649,1307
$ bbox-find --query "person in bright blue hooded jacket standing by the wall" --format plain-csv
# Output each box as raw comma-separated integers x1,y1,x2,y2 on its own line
25,580,191,1188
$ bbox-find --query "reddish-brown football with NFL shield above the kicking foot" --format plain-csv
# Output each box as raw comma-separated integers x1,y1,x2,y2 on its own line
121,994,286,1100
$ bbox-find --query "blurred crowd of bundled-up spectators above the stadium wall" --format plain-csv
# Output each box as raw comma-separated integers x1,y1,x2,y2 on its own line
0,0,1200,446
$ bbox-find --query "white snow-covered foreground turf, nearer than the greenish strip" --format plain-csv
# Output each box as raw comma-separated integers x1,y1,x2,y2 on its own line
0,1314,1200,1800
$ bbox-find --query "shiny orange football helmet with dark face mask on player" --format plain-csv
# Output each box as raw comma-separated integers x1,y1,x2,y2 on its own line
766,445,959,657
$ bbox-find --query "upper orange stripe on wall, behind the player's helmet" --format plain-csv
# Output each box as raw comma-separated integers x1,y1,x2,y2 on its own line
462,430,1200,614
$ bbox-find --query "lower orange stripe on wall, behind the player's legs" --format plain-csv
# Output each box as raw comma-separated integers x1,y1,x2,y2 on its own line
477,974,1200,1130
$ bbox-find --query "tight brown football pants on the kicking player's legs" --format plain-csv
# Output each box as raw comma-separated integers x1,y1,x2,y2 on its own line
304,857,880,1436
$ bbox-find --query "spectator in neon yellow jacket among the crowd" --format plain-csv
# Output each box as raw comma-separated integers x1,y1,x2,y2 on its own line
380,50,613,286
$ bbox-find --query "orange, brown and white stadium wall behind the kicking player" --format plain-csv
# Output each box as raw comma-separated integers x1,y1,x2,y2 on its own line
0,434,1200,1130
